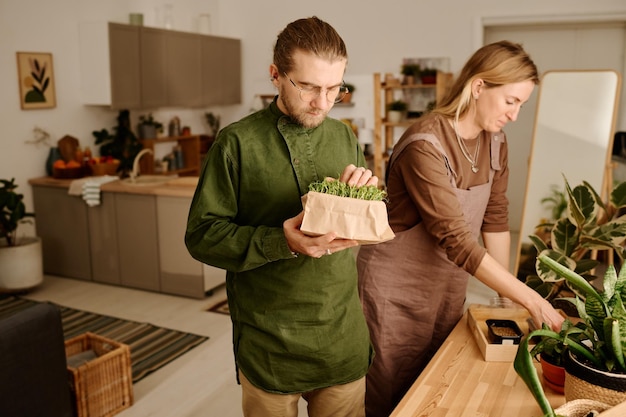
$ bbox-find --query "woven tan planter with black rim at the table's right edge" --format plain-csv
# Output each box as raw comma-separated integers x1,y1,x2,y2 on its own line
565,352,626,405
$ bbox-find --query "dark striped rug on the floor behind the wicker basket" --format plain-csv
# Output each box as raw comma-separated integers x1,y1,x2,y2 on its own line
0,296,208,382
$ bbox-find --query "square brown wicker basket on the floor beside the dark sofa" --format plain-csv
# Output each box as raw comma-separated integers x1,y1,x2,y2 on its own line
65,332,133,417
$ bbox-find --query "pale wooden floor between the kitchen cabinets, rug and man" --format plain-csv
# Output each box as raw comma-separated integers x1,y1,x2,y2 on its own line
23,276,492,417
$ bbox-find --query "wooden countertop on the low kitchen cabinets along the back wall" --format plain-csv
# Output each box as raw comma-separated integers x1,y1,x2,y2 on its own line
28,177,198,198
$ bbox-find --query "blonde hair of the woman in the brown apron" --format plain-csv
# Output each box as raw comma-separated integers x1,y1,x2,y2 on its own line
433,41,539,121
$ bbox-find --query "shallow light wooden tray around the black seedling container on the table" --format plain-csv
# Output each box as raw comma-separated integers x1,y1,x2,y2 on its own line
467,304,530,362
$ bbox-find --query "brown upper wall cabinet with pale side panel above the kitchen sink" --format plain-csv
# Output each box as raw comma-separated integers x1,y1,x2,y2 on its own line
80,23,241,109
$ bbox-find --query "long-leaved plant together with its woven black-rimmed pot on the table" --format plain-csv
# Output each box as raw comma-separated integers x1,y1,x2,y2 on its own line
513,251,626,416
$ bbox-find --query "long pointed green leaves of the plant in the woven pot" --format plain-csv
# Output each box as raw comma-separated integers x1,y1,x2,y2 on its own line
513,255,626,417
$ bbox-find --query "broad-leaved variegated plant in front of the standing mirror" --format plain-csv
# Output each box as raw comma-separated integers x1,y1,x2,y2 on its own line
526,179,626,301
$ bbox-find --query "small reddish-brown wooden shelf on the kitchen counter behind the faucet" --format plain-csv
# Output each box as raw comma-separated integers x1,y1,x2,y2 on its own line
139,135,213,176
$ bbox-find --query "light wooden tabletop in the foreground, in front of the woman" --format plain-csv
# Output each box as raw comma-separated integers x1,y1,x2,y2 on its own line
390,312,626,417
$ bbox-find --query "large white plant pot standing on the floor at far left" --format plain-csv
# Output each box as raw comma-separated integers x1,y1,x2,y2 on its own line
0,237,43,292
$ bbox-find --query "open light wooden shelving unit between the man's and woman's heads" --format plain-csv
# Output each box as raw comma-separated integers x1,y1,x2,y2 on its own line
371,72,452,181
